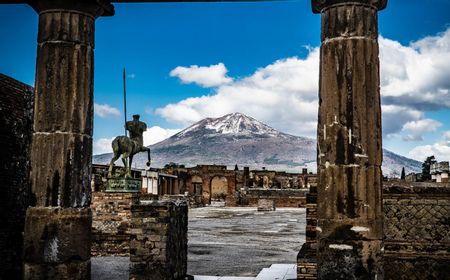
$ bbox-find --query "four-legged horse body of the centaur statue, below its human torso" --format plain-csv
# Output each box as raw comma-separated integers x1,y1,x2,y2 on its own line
108,136,151,178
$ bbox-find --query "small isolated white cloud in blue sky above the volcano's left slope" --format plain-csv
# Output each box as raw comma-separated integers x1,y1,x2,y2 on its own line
170,63,233,87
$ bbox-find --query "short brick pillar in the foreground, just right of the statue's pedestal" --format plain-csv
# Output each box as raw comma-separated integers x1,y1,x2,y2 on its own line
130,200,188,280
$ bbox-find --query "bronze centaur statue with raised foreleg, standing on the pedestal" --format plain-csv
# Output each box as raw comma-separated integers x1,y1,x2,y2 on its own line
108,115,150,177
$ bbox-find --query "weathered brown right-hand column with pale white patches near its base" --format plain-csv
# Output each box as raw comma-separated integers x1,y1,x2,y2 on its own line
312,0,387,280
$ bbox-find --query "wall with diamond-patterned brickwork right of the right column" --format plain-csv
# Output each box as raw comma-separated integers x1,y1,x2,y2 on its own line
383,184,450,280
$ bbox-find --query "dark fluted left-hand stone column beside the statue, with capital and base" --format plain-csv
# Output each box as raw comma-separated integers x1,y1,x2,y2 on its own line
24,0,114,279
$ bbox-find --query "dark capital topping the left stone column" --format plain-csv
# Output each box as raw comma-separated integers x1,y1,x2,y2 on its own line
28,0,114,18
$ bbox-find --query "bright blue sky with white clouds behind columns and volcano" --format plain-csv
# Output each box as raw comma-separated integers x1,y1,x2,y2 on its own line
0,0,450,160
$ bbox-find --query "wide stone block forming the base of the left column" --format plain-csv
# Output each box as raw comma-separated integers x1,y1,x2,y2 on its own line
24,207,92,280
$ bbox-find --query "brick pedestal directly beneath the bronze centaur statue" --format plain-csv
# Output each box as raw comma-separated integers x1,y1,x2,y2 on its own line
91,192,138,256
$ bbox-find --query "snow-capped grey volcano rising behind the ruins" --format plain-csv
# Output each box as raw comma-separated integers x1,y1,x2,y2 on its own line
94,113,421,175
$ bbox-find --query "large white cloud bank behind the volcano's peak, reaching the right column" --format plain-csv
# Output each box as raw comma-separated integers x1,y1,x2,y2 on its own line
156,51,319,136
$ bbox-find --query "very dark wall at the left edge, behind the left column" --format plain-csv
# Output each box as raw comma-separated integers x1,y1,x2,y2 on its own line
0,74,33,279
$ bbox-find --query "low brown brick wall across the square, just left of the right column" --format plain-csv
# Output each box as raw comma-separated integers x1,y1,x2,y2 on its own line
241,189,308,208
